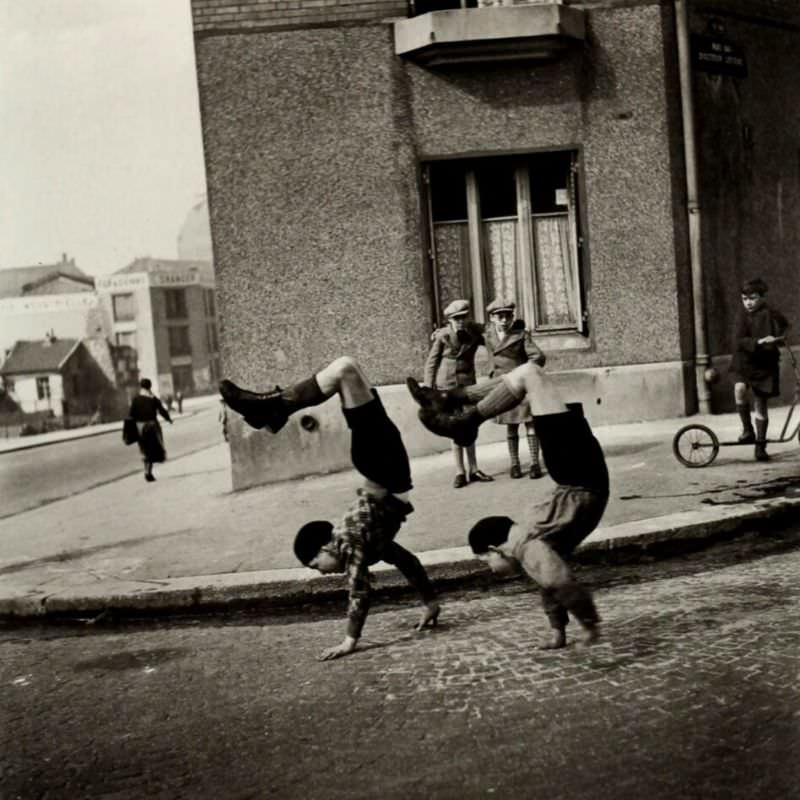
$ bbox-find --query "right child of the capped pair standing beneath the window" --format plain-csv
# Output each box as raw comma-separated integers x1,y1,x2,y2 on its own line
484,298,545,478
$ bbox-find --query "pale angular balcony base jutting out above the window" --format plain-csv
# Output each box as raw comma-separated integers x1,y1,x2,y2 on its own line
394,2,586,67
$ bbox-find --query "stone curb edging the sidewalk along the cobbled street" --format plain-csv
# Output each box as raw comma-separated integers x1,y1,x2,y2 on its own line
0,498,800,621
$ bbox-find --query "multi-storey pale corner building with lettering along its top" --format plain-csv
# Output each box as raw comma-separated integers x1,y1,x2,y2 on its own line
96,258,220,396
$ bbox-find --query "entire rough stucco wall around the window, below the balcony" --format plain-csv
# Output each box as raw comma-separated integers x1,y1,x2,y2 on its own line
197,3,683,396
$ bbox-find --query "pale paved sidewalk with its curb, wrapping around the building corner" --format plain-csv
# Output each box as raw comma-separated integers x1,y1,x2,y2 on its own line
0,409,800,617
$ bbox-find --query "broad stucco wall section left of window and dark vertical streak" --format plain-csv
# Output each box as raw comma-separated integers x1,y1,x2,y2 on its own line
197,25,430,383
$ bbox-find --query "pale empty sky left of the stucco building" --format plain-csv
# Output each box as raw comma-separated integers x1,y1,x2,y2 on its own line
0,0,205,275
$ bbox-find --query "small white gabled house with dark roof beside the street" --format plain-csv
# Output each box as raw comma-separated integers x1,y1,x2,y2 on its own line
0,333,135,422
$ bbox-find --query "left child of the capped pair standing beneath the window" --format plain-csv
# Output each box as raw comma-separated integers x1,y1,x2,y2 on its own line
424,300,494,489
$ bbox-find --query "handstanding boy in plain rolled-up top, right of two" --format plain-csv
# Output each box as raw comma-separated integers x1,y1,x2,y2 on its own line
407,361,609,649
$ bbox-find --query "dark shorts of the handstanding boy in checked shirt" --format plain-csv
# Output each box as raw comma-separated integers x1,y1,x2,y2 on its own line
342,389,412,494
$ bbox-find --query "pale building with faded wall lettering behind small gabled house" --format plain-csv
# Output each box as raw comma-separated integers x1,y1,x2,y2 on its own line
0,253,105,361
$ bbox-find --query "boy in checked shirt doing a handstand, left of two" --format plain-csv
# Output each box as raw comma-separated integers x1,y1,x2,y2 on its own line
219,356,439,660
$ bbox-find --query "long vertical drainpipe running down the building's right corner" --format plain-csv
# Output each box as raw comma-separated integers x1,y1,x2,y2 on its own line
674,0,711,414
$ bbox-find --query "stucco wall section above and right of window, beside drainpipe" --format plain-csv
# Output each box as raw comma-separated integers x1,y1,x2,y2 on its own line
410,5,681,368
